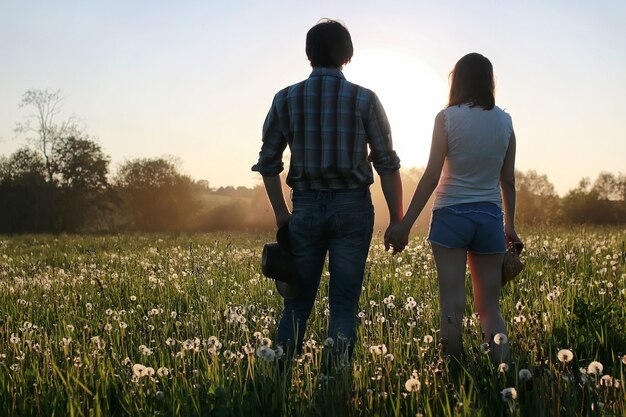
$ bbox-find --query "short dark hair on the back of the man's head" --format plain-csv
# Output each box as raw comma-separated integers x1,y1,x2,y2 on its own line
306,19,354,68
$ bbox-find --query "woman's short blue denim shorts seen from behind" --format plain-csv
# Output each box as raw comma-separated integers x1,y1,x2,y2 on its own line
428,203,506,255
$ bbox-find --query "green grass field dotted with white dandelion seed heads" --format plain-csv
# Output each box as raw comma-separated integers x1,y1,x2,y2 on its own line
0,228,626,417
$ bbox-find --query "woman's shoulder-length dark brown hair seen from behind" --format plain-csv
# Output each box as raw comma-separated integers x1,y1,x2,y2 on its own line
448,52,496,110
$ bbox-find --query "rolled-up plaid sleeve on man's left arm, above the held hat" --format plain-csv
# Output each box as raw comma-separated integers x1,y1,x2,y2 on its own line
252,95,287,177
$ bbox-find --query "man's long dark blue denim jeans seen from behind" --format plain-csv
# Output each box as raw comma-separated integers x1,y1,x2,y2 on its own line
278,189,374,355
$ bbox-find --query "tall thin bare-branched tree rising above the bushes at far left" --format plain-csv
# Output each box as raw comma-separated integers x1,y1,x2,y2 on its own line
14,89,80,182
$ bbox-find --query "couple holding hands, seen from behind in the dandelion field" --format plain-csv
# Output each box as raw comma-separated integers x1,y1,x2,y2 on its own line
252,19,522,362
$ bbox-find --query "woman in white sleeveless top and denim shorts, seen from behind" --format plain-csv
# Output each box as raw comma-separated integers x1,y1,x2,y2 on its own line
385,53,522,362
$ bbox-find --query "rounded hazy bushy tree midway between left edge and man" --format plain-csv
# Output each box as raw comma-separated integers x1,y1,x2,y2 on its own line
114,158,198,231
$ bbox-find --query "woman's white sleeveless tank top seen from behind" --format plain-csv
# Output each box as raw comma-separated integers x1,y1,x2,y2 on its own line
433,104,513,210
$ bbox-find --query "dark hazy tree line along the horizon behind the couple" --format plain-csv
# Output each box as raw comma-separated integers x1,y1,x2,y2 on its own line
0,90,626,233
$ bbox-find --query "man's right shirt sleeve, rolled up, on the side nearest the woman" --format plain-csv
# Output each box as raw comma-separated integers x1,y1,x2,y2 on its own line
365,94,400,175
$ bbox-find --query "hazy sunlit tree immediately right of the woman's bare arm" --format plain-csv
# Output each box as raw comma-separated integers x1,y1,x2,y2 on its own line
515,170,561,224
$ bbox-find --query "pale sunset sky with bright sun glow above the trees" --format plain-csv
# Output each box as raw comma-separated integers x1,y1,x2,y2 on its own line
0,0,626,195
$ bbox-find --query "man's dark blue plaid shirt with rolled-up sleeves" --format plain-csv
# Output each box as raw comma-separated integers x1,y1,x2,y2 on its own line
252,68,400,190
